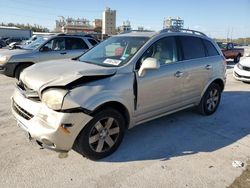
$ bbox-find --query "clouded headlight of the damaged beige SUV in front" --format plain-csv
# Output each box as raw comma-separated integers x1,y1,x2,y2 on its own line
42,89,68,110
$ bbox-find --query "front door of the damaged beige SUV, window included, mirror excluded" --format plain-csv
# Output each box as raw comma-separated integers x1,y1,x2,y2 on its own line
135,37,183,123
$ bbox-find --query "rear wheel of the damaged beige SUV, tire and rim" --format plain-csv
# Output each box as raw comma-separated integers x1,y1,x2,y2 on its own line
198,83,222,115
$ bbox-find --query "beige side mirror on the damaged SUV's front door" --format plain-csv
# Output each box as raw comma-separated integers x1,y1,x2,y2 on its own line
138,57,160,77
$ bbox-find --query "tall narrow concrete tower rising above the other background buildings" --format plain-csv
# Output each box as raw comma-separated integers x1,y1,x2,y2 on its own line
102,8,116,35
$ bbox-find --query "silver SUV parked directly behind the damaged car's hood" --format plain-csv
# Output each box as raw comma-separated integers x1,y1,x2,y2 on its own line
0,34,98,79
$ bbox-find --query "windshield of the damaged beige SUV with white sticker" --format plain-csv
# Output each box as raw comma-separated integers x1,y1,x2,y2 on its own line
79,36,149,67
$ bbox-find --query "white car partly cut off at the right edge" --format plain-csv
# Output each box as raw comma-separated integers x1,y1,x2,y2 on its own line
233,54,250,83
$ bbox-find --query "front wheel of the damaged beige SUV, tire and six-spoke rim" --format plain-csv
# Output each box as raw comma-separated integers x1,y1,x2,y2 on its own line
74,108,125,160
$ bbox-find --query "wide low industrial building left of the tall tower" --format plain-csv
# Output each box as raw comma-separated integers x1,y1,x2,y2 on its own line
55,17,94,33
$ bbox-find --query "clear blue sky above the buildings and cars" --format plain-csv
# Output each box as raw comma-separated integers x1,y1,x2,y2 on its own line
0,0,250,38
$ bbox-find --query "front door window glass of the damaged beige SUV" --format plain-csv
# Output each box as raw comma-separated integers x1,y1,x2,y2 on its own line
136,37,178,69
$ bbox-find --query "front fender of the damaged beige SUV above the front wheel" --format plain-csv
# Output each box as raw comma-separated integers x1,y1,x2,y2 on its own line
62,74,135,120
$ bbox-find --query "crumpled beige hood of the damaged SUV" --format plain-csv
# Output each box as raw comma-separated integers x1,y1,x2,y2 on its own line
20,59,117,91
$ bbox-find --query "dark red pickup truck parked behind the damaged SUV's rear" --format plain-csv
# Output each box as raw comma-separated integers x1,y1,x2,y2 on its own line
217,42,244,63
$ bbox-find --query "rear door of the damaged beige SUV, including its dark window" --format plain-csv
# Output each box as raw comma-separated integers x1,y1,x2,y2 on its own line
178,36,216,105
